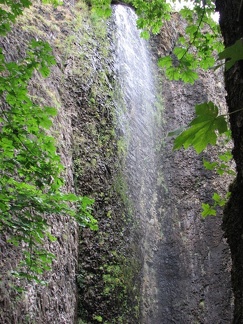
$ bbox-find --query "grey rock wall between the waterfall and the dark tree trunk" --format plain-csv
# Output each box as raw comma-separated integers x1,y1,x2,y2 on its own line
148,15,233,323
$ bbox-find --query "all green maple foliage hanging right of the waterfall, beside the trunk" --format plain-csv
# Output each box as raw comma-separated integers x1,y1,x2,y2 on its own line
127,0,237,217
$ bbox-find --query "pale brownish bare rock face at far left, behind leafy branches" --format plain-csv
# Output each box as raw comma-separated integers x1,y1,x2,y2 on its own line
0,4,81,323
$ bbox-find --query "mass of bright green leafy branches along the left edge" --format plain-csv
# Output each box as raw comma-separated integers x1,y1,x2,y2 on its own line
0,0,97,282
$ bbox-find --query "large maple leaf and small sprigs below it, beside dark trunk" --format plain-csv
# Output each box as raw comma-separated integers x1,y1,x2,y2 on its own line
169,102,235,218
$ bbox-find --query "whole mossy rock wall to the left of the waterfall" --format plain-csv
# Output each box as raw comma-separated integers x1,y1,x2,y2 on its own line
0,0,140,324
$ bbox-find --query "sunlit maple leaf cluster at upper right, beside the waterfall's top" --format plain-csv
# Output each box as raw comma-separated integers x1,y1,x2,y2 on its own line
159,1,223,84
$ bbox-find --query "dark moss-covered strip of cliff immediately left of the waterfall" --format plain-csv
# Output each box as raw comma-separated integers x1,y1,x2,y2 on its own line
64,9,140,323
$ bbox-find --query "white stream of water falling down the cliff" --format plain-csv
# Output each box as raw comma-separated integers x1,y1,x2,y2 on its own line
114,5,160,324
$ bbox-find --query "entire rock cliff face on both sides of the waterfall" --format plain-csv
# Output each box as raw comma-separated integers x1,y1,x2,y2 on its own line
0,0,234,324
